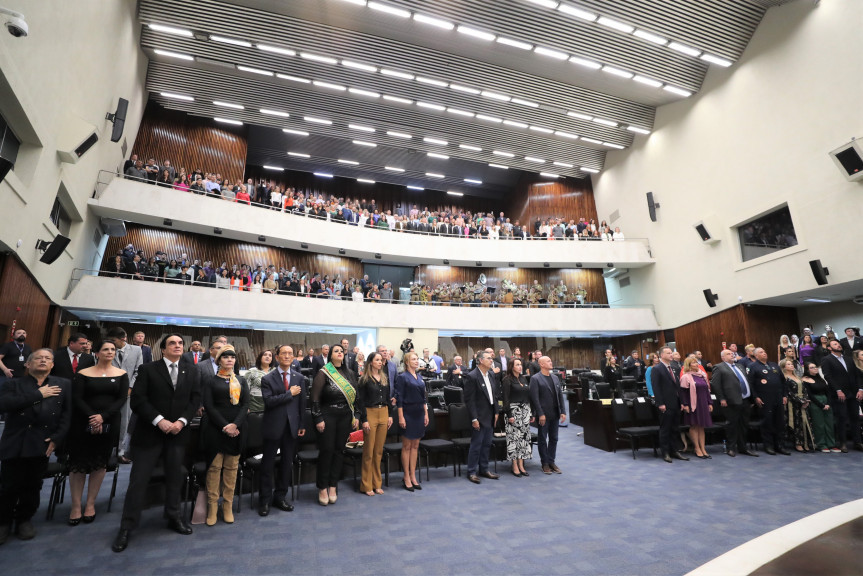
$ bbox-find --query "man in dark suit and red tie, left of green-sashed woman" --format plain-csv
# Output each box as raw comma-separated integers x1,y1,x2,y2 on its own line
258,346,306,516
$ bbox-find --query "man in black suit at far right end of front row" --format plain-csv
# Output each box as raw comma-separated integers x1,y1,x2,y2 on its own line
821,340,863,452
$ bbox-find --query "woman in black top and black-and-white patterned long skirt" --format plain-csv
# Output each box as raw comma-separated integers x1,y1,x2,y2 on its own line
503,358,533,477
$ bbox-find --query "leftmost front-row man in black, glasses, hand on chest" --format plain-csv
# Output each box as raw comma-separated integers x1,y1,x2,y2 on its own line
0,348,72,544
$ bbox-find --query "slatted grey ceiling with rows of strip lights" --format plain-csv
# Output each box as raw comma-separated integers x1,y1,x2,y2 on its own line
133,0,783,194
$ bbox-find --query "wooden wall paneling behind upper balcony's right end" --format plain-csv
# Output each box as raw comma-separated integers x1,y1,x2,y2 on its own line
506,174,601,231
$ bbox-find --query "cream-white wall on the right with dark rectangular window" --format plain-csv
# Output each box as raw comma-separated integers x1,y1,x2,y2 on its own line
594,1,863,327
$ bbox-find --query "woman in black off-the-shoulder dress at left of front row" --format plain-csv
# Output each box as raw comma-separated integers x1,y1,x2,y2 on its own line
68,340,129,526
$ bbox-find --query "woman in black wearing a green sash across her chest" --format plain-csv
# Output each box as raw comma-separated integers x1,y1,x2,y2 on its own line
312,344,358,506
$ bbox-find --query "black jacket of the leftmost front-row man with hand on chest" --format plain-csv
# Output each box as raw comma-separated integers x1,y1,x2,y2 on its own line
0,374,72,460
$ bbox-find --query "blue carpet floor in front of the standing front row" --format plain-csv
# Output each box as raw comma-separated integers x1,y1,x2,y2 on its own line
0,426,863,576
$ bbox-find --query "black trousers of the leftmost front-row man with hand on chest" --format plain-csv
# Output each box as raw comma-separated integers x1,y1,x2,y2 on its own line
0,456,48,526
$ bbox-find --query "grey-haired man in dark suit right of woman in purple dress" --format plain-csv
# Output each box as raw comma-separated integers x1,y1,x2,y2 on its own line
710,350,758,458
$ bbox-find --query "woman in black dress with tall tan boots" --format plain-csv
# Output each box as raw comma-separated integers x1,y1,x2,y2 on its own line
201,345,249,526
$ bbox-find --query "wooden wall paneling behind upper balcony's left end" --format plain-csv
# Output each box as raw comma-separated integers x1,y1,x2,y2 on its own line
131,100,248,182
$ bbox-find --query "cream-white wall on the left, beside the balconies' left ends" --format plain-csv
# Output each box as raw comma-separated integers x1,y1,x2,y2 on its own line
0,0,146,301
